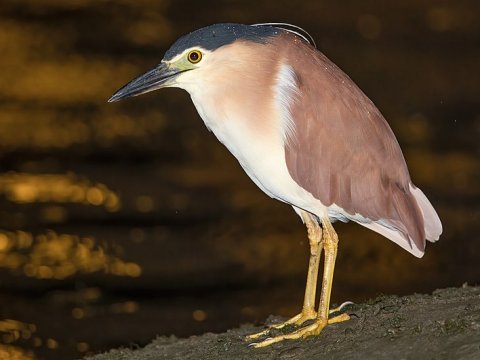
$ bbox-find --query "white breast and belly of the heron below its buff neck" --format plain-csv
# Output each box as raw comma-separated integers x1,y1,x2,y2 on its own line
189,67,326,216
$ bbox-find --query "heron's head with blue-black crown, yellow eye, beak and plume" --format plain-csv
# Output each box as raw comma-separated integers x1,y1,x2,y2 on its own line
108,23,315,102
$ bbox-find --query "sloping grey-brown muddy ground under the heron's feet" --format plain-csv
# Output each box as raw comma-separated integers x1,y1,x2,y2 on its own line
85,286,480,360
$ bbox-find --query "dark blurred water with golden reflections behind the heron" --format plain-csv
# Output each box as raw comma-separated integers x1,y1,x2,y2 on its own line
0,0,480,359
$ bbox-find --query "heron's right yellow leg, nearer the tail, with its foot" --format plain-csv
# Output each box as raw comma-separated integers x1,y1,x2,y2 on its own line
253,218,348,347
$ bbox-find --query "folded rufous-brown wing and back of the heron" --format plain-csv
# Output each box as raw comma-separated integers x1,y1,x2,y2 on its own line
285,36,430,256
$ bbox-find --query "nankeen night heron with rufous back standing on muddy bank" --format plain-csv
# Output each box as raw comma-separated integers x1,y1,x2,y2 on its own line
109,23,442,347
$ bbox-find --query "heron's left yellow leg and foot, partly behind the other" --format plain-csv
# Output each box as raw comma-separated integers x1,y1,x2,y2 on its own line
247,212,323,339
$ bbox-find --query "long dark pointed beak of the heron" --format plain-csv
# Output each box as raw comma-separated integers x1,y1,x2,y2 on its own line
108,62,182,102
